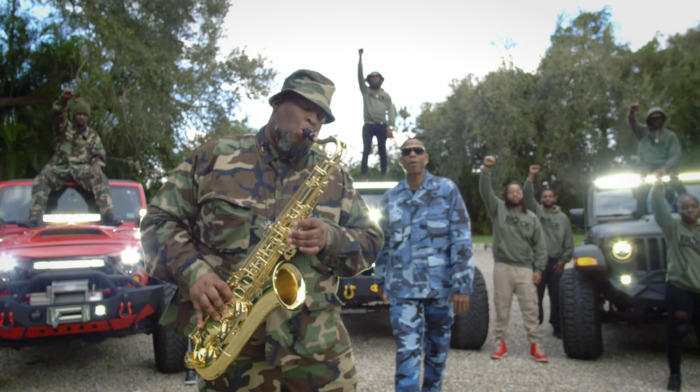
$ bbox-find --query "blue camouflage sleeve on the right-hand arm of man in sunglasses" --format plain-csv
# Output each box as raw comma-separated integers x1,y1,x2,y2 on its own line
449,185,474,294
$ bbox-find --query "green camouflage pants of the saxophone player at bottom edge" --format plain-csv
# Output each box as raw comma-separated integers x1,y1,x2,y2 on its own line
197,348,357,392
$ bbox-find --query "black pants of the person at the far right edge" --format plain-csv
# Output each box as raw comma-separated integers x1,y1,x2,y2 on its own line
666,282,700,374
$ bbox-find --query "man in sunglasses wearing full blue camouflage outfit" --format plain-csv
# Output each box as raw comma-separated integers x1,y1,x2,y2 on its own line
375,139,474,392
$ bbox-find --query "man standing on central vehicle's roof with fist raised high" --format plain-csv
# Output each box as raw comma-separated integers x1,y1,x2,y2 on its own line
357,49,396,181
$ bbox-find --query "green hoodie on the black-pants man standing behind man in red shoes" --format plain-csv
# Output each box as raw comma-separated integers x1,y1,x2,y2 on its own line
523,180,574,264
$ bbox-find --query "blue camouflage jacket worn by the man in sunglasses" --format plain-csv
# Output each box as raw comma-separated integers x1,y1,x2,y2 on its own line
374,172,474,298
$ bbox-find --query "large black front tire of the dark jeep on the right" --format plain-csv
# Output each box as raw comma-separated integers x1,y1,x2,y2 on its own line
559,269,603,359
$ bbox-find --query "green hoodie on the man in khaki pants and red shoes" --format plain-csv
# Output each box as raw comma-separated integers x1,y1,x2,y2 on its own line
479,170,547,273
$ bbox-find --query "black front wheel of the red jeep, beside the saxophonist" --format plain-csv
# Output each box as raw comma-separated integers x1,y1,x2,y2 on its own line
153,283,188,373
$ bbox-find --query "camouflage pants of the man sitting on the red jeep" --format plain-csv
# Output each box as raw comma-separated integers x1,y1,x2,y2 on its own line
29,165,114,216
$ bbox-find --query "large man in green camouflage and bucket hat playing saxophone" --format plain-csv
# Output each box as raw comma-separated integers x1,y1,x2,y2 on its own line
141,70,383,392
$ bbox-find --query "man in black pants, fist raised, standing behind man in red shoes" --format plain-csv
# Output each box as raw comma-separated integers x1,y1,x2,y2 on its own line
523,165,574,339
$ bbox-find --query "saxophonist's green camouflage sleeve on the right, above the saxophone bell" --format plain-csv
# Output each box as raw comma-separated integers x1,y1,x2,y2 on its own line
319,170,384,277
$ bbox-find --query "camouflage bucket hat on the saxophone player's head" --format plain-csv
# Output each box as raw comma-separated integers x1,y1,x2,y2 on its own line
269,69,335,124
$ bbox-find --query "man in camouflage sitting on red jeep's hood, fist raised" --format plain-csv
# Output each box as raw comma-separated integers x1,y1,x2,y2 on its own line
18,88,122,227
